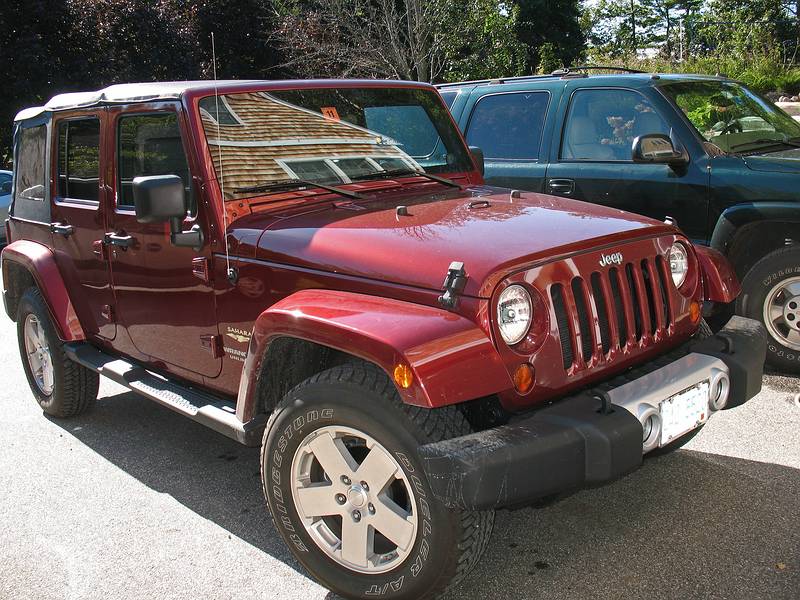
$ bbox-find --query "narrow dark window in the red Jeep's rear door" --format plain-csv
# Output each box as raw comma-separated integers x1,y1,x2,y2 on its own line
58,119,100,202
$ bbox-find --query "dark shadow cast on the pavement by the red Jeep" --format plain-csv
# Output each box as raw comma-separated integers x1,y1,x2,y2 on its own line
52,392,800,600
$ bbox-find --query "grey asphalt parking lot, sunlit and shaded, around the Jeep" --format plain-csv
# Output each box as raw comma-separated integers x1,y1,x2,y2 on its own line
0,308,800,600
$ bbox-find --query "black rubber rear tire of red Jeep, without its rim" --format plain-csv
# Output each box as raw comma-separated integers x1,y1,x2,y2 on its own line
17,288,100,418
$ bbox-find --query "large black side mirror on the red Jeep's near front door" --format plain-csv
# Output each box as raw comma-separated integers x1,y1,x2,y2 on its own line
133,175,203,250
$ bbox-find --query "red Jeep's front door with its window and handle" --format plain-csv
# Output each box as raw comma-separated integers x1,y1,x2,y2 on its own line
106,104,222,379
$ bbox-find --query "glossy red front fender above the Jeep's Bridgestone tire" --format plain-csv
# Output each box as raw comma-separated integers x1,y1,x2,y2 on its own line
239,290,513,408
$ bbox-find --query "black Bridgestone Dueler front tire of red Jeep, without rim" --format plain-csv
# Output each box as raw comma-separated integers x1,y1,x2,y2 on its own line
261,363,494,600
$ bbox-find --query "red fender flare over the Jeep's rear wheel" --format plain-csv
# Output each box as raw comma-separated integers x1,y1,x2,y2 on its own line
2,240,86,342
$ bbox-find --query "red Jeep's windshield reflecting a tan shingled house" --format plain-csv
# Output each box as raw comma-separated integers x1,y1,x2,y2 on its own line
199,88,472,200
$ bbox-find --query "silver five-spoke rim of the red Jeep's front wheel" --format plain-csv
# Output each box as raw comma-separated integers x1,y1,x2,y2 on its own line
292,426,417,574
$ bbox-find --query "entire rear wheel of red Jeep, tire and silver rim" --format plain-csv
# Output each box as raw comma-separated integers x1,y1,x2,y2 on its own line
17,288,100,418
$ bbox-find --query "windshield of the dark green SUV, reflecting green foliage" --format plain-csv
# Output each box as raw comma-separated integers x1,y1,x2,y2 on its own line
661,81,800,152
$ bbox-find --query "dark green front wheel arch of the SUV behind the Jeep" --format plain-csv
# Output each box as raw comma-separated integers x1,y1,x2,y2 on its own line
711,202,800,280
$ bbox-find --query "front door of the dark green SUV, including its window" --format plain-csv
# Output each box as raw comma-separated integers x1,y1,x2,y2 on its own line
545,84,709,241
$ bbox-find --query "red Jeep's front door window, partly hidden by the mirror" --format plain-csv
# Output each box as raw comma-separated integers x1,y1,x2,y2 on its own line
117,113,195,214
